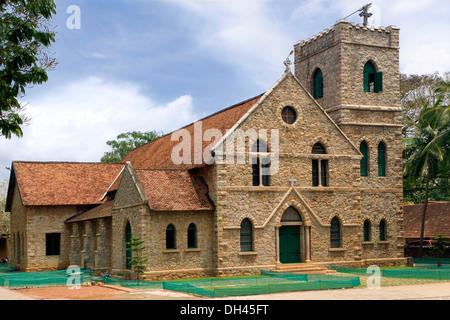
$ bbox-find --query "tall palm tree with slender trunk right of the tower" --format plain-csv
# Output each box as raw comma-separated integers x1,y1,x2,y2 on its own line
403,94,450,256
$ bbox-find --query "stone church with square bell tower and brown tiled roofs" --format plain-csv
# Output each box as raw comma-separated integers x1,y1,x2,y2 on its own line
6,20,406,279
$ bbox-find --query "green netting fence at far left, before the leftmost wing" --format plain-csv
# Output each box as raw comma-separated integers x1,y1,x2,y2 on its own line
0,265,99,288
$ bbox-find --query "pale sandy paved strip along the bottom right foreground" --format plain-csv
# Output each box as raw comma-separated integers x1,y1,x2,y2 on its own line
220,282,450,300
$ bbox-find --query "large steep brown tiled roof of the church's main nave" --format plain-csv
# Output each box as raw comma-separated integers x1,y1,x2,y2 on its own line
122,95,262,169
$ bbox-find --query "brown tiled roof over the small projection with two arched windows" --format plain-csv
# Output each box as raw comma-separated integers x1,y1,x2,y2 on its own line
135,169,214,211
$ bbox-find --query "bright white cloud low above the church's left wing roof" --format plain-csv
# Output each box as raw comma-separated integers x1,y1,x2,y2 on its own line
0,78,198,178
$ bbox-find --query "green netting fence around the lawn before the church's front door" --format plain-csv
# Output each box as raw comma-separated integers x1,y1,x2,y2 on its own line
105,270,361,298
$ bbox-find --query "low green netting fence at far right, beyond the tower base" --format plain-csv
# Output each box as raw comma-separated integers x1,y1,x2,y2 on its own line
331,266,450,280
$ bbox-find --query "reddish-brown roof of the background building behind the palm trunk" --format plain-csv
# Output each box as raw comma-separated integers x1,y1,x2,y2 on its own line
403,201,450,238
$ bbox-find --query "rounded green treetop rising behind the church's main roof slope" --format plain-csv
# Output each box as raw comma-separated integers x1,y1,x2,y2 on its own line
101,131,163,163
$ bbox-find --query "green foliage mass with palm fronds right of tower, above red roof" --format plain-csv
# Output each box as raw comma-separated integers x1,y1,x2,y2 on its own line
402,74,450,203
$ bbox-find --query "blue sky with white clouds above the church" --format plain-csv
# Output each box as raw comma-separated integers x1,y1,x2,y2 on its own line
0,0,450,181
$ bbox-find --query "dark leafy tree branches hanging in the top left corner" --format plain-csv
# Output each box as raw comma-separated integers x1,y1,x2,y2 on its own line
0,0,56,139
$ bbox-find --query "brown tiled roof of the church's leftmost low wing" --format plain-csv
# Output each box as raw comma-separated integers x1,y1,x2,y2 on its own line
13,161,123,206
